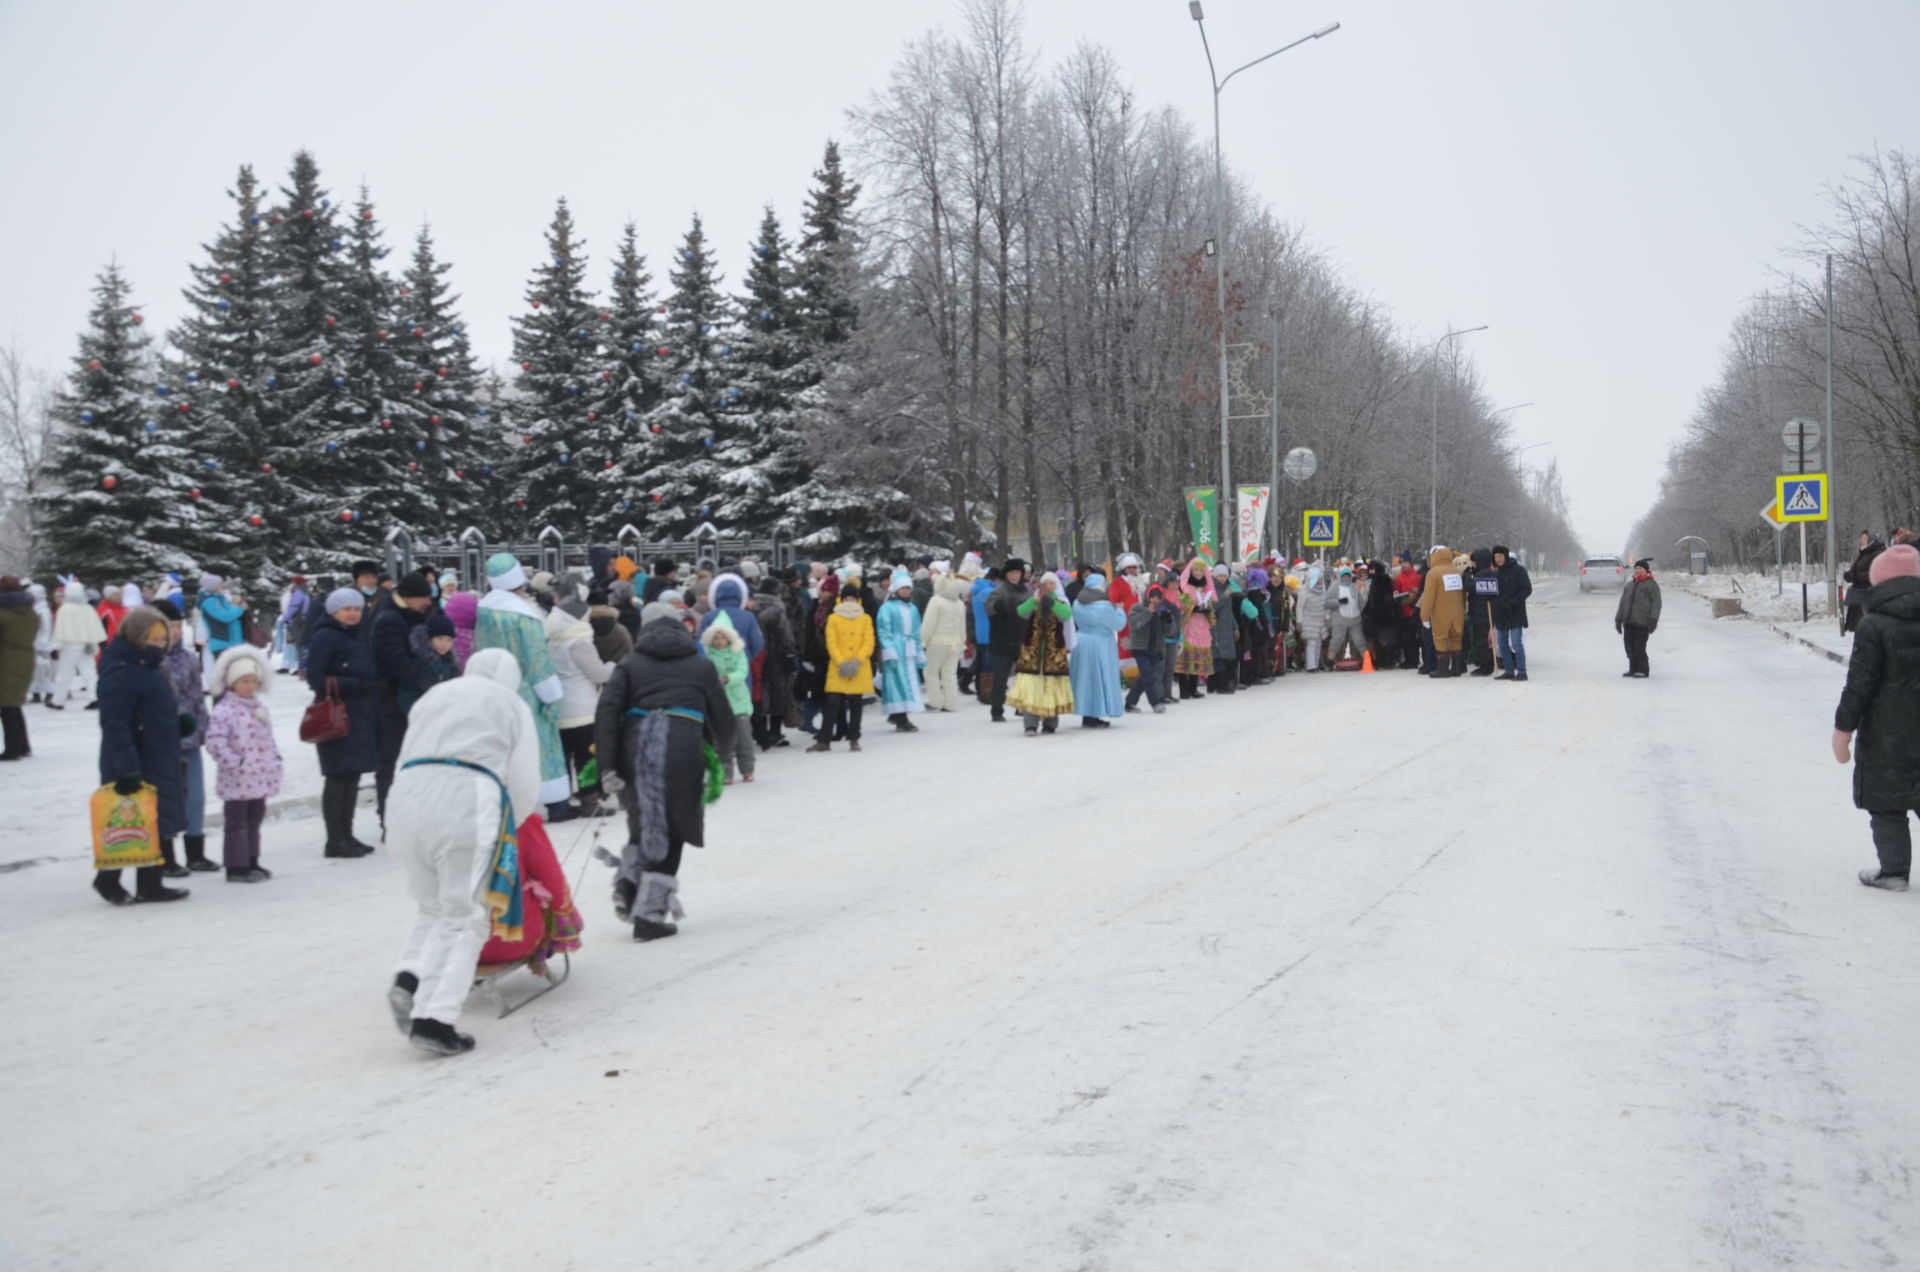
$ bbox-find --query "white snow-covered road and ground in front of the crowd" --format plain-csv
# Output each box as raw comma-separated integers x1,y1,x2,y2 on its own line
0,582,1920,1272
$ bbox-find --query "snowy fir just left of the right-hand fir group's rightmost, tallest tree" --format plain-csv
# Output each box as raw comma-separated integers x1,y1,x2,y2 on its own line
712,208,812,536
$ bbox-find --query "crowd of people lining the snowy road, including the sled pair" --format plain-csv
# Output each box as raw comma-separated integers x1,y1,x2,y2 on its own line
0,546,1697,1053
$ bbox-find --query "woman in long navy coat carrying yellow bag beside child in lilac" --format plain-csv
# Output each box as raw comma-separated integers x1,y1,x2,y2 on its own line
94,605,194,905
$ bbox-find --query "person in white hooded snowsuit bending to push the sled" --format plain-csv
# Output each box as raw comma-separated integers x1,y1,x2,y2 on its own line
386,649,541,1055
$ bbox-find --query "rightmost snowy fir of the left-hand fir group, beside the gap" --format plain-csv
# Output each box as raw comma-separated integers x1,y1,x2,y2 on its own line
386,225,487,540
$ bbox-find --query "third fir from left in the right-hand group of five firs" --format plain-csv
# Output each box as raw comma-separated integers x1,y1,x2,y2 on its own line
634,217,733,538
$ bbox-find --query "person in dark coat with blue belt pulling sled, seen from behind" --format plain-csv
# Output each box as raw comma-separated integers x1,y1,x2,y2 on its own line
593,601,733,942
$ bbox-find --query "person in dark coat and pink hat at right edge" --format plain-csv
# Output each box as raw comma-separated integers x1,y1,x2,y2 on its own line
1834,544,1920,892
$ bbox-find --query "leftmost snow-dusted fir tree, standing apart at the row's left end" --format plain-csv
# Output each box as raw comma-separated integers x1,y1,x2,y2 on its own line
35,265,209,588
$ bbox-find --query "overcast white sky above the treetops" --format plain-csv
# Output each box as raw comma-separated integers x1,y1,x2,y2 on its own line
0,0,1920,550
